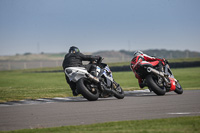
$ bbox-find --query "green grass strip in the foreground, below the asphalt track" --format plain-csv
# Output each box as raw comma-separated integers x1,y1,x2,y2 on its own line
1,116,200,133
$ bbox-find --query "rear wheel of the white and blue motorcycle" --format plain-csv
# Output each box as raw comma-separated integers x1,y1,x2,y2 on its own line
76,78,99,101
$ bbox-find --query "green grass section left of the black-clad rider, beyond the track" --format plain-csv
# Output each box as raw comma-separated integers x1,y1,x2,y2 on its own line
0,71,72,102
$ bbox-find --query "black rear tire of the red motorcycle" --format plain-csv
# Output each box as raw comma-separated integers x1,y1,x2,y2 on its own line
146,75,166,96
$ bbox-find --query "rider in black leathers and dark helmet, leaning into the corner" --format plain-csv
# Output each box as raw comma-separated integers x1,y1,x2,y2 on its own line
62,46,101,96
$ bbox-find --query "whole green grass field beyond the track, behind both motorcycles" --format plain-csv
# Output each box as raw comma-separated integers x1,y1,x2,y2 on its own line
0,67,200,102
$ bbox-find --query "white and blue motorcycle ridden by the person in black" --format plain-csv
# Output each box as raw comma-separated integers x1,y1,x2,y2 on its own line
65,58,124,101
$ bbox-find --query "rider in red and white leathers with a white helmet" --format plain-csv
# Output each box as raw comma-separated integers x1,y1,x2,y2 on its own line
130,51,165,88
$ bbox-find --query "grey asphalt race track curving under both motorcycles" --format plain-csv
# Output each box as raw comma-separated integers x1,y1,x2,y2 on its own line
0,90,200,131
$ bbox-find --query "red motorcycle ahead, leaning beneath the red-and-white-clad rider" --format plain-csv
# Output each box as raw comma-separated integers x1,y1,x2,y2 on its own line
130,60,183,95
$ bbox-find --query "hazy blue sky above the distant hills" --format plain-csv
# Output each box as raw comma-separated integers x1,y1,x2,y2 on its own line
0,0,200,55
